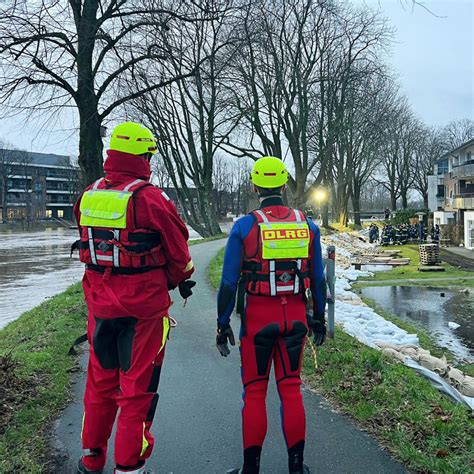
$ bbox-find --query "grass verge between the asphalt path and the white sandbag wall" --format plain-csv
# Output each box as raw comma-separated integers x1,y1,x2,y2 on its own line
208,250,474,474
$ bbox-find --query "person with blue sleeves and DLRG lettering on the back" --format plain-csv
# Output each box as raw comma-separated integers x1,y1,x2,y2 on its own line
216,157,326,474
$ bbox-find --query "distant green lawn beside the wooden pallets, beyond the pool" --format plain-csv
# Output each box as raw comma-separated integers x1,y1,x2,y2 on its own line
364,244,474,286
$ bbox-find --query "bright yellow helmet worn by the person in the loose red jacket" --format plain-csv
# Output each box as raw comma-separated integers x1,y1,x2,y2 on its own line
110,122,156,155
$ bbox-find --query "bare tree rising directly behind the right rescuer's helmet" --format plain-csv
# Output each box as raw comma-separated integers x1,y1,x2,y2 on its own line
225,0,390,207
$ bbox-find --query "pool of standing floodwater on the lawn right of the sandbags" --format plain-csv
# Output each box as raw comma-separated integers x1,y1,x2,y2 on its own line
362,286,474,362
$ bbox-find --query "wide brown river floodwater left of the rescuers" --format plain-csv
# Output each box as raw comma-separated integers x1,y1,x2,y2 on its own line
0,228,200,328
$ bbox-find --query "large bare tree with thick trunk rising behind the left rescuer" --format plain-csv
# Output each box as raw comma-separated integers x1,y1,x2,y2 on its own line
0,0,215,183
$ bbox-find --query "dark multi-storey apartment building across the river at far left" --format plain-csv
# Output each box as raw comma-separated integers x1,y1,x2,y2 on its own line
0,149,80,220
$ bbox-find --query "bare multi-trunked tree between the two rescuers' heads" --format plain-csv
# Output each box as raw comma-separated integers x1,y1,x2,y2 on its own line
134,0,238,236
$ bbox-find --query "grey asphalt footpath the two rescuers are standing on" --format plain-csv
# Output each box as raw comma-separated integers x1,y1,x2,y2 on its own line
53,240,408,474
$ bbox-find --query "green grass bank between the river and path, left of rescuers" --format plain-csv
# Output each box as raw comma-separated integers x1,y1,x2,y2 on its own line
0,284,86,473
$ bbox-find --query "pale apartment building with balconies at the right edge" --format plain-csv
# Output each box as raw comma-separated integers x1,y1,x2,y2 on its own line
428,139,474,249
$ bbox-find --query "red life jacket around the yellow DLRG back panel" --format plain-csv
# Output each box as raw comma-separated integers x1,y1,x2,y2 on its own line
240,208,310,296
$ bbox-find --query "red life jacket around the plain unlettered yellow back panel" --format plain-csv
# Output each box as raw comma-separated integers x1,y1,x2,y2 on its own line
76,178,166,274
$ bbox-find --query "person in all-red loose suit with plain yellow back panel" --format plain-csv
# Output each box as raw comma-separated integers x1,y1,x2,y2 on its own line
74,122,194,474
